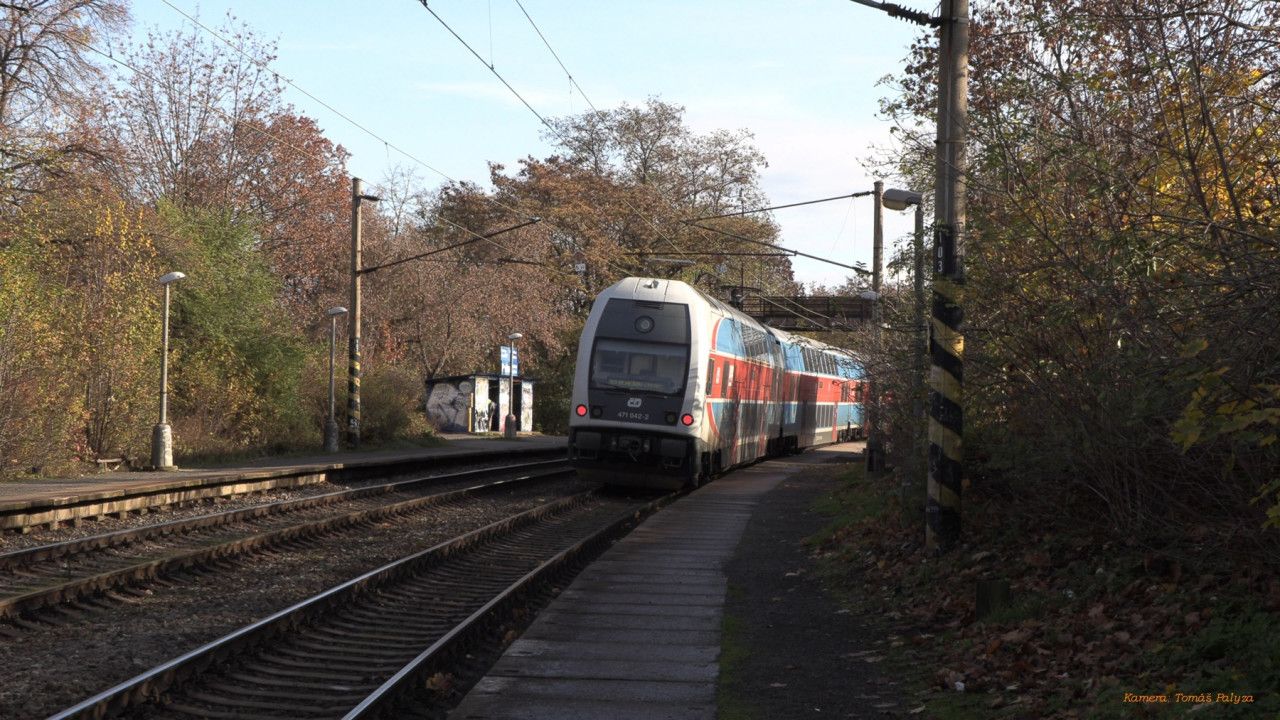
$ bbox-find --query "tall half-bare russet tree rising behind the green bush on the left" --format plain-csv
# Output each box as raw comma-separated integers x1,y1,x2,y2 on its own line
111,18,351,317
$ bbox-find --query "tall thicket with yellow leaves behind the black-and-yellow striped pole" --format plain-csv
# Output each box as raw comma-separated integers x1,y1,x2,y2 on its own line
886,0,1280,545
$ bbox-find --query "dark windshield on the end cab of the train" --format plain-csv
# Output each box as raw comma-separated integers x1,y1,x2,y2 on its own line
591,338,689,395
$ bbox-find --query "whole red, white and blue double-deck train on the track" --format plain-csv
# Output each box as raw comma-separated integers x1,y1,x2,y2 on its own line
568,278,865,488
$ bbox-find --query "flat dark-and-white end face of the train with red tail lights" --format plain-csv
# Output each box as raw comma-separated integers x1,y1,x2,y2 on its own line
568,292,705,488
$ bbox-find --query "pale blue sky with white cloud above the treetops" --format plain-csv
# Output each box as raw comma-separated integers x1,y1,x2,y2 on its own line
132,0,936,284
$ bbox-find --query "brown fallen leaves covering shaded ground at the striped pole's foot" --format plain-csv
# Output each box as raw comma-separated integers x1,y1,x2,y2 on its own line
815,474,1280,719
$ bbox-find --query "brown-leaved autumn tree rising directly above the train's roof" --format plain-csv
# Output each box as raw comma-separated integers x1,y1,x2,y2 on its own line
537,99,794,297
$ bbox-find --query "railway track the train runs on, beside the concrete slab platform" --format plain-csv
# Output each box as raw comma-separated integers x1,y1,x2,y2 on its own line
54,491,673,719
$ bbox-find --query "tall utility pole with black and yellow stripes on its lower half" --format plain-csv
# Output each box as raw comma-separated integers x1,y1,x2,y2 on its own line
924,0,969,555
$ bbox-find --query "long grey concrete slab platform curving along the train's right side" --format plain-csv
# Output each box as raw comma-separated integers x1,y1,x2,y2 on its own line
449,443,861,720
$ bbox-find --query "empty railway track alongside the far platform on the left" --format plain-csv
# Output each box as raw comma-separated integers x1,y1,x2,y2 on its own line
0,460,571,621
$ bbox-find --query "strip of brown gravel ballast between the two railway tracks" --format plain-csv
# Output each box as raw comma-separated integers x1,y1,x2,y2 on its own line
0,480,584,719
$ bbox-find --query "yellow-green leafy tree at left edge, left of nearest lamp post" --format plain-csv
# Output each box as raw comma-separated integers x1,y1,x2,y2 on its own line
0,180,160,471
